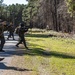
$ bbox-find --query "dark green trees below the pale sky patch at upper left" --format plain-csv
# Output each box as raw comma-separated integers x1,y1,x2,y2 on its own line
0,4,25,24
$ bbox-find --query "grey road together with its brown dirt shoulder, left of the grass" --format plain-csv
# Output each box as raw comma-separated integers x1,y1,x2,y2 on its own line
0,33,35,75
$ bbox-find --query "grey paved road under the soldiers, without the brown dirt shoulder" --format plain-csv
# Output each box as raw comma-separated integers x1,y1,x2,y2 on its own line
0,32,18,75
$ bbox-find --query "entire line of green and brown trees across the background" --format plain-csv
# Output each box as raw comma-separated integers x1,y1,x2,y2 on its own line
0,0,75,33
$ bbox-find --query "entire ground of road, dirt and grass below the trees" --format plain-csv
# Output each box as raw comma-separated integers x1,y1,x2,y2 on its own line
0,31,75,75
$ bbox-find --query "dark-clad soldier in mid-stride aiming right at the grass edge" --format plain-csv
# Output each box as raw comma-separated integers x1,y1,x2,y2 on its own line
16,23,28,49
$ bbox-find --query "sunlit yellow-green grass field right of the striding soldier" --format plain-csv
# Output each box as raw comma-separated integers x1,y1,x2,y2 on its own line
25,33,75,75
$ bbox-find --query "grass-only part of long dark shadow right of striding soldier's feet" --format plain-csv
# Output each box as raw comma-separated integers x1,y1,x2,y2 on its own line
26,48,75,59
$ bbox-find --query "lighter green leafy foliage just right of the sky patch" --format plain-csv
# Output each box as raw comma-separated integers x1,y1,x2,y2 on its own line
22,0,39,24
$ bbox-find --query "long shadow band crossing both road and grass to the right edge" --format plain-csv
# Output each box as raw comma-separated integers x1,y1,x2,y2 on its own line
3,48,75,59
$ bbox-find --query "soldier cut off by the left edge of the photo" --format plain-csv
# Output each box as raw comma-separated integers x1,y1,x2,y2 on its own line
0,19,5,52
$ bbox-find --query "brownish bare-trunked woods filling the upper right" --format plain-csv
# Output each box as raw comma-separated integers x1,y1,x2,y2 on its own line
25,0,75,33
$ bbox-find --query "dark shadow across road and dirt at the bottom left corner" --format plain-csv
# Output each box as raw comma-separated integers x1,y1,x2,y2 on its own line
0,63,33,71
